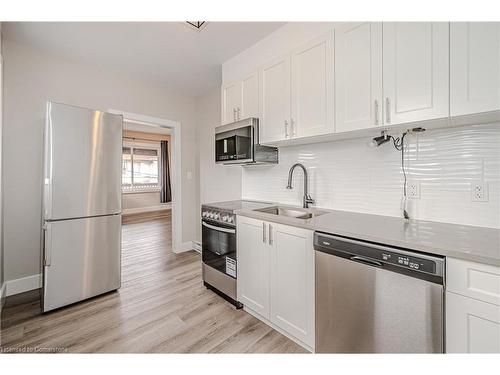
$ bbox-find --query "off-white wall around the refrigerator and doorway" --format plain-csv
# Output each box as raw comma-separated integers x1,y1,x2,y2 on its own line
3,39,198,280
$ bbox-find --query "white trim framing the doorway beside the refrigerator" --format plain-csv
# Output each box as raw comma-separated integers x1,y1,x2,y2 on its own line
108,109,185,253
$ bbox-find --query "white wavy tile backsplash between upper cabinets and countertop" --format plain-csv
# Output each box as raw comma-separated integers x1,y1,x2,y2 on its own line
242,123,500,228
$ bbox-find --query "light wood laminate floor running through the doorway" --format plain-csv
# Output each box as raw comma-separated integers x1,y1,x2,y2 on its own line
0,212,305,353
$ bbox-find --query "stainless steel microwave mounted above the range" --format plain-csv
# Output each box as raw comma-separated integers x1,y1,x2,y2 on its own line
215,117,278,165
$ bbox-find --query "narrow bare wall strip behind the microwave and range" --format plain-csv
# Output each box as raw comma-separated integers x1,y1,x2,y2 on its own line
196,88,241,241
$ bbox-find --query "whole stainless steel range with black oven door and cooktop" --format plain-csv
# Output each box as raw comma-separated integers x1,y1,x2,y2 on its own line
201,200,268,308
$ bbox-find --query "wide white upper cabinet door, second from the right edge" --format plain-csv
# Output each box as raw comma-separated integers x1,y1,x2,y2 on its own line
383,22,449,125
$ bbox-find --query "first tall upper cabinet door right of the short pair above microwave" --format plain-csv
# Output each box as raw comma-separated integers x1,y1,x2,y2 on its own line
260,55,290,143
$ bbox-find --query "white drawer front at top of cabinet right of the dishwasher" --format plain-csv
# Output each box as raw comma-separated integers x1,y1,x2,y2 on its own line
446,258,500,306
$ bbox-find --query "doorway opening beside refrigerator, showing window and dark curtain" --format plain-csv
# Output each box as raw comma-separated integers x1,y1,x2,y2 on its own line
109,110,184,254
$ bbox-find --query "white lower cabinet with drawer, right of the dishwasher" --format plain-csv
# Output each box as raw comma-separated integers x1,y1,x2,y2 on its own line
446,258,500,353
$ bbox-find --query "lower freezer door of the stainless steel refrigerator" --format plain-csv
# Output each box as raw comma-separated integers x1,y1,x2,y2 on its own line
43,215,121,312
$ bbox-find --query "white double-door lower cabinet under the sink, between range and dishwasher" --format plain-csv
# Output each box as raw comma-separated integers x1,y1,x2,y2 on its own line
237,216,314,349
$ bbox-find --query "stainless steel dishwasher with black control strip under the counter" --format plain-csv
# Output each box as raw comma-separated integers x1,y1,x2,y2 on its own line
314,232,445,353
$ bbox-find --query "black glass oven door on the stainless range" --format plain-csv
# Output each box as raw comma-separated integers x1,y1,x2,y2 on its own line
201,220,236,278
